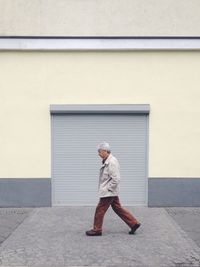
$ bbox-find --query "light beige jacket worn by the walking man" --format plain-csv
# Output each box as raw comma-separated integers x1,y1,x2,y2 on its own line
99,154,120,198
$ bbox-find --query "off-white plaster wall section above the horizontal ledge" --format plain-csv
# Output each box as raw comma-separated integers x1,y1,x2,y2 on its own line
0,0,200,36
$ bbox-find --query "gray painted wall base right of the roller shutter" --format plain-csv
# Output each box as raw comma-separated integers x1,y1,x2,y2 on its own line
148,178,200,207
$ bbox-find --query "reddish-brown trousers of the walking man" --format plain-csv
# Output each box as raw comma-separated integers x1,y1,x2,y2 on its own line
93,196,138,232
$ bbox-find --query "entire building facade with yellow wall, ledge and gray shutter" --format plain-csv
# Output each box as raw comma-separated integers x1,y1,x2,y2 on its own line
0,0,200,207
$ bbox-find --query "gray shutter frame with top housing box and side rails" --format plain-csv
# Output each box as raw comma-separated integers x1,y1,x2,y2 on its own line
50,104,150,206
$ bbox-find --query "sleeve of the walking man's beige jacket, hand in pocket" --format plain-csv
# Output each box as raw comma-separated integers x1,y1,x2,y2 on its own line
108,162,120,192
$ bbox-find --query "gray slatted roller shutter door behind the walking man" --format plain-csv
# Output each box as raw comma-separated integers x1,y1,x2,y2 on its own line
52,114,148,206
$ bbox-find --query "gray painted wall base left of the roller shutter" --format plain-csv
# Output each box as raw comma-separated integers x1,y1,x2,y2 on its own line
0,178,51,207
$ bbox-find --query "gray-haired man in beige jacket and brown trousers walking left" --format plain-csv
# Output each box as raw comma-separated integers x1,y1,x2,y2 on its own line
86,142,140,236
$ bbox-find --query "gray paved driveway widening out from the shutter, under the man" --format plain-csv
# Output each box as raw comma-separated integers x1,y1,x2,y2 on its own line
0,207,200,267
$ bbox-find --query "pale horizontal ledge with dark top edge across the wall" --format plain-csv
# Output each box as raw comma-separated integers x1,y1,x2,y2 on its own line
0,36,200,51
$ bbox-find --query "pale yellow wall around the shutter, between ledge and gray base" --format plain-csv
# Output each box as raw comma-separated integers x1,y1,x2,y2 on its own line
0,51,200,178
